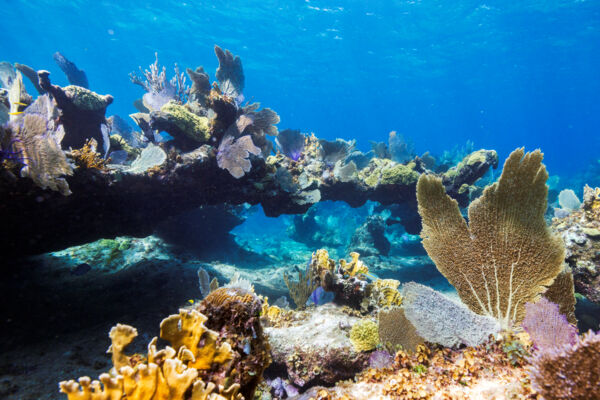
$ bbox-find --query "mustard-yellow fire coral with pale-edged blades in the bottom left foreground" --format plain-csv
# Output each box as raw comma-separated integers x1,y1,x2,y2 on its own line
59,310,243,400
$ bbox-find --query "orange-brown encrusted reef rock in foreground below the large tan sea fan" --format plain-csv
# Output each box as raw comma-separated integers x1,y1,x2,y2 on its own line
302,341,536,400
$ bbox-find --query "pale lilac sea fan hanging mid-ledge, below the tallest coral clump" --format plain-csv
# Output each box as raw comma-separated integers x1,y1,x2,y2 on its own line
217,135,260,179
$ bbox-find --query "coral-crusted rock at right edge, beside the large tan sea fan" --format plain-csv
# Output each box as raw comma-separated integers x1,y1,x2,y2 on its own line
552,186,600,304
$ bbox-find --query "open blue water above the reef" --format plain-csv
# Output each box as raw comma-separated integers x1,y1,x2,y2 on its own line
0,0,600,174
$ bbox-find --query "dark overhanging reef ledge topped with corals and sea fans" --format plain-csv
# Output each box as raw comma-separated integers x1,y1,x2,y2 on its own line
0,50,495,256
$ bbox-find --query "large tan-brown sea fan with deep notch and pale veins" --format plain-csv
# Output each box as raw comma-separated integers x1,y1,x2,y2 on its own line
417,149,564,328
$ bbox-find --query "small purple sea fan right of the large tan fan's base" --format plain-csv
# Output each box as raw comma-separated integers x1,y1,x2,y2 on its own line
521,297,577,352
